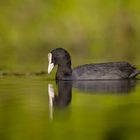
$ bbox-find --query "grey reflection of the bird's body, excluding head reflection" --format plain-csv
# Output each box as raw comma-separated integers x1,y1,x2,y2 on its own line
73,80,136,94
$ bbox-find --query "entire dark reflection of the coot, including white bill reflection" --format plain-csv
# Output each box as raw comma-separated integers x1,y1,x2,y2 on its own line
48,80,136,118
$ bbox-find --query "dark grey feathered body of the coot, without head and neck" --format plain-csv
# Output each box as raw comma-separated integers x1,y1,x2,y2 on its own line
72,62,139,80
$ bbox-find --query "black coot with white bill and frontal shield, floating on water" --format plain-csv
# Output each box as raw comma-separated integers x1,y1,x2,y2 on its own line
48,48,140,80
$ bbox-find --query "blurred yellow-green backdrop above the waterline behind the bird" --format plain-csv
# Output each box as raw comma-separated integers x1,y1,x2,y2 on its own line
0,0,140,72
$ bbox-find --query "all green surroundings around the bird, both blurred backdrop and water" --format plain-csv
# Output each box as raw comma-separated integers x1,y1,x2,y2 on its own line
0,0,140,140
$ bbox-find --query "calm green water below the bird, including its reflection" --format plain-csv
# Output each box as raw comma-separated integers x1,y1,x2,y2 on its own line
0,76,140,140
